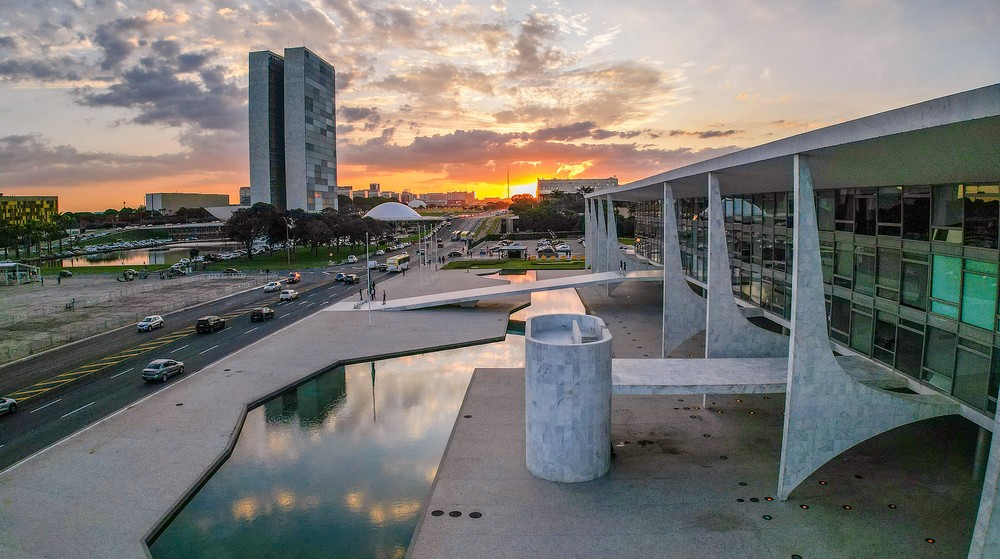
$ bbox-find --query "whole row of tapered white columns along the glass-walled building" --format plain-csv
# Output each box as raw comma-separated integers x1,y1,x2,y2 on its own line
587,155,1000,559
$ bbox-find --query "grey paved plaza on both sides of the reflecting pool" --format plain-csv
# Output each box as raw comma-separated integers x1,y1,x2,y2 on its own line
0,271,981,559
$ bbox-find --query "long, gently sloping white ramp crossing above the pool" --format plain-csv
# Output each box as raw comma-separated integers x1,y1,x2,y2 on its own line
324,270,663,311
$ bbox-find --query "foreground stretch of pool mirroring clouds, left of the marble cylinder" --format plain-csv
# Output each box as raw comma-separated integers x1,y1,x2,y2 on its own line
152,336,524,559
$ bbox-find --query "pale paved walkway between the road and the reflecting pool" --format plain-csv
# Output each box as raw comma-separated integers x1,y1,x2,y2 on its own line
0,272,527,559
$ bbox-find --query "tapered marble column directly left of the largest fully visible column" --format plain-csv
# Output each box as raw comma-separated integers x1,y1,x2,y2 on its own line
705,173,788,357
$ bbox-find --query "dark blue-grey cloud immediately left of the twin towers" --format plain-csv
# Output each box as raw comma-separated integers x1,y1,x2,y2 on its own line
77,53,247,130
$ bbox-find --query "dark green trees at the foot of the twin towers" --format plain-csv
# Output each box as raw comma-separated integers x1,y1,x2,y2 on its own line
223,203,389,260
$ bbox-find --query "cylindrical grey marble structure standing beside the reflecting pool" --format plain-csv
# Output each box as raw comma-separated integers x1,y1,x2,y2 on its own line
524,314,611,482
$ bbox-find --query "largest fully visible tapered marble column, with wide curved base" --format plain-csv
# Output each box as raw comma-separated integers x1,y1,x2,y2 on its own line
778,155,958,500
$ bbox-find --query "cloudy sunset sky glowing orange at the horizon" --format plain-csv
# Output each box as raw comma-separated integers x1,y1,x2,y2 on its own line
0,0,1000,211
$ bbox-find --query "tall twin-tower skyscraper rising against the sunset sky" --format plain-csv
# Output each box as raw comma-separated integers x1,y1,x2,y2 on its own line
250,47,337,211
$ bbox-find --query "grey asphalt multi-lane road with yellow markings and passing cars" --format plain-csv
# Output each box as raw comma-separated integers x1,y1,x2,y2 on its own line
0,220,474,471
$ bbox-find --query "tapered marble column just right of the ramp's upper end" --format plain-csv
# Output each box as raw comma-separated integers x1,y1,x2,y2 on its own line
661,183,706,358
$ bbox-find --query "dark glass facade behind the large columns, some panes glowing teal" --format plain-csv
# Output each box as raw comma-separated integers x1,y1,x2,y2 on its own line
660,183,1000,415
